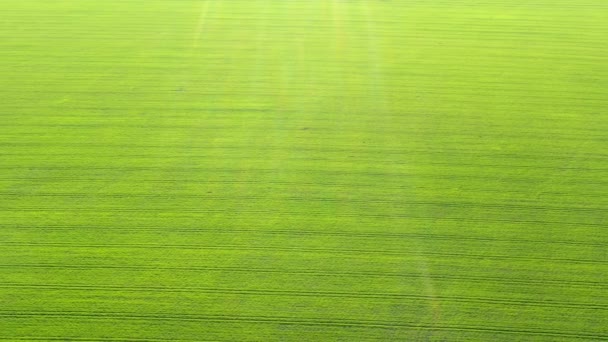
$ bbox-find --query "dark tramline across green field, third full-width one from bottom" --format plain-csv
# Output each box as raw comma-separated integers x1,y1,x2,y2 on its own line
0,263,608,289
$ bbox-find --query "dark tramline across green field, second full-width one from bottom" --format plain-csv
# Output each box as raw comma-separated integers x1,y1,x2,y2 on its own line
0,283,608,310
